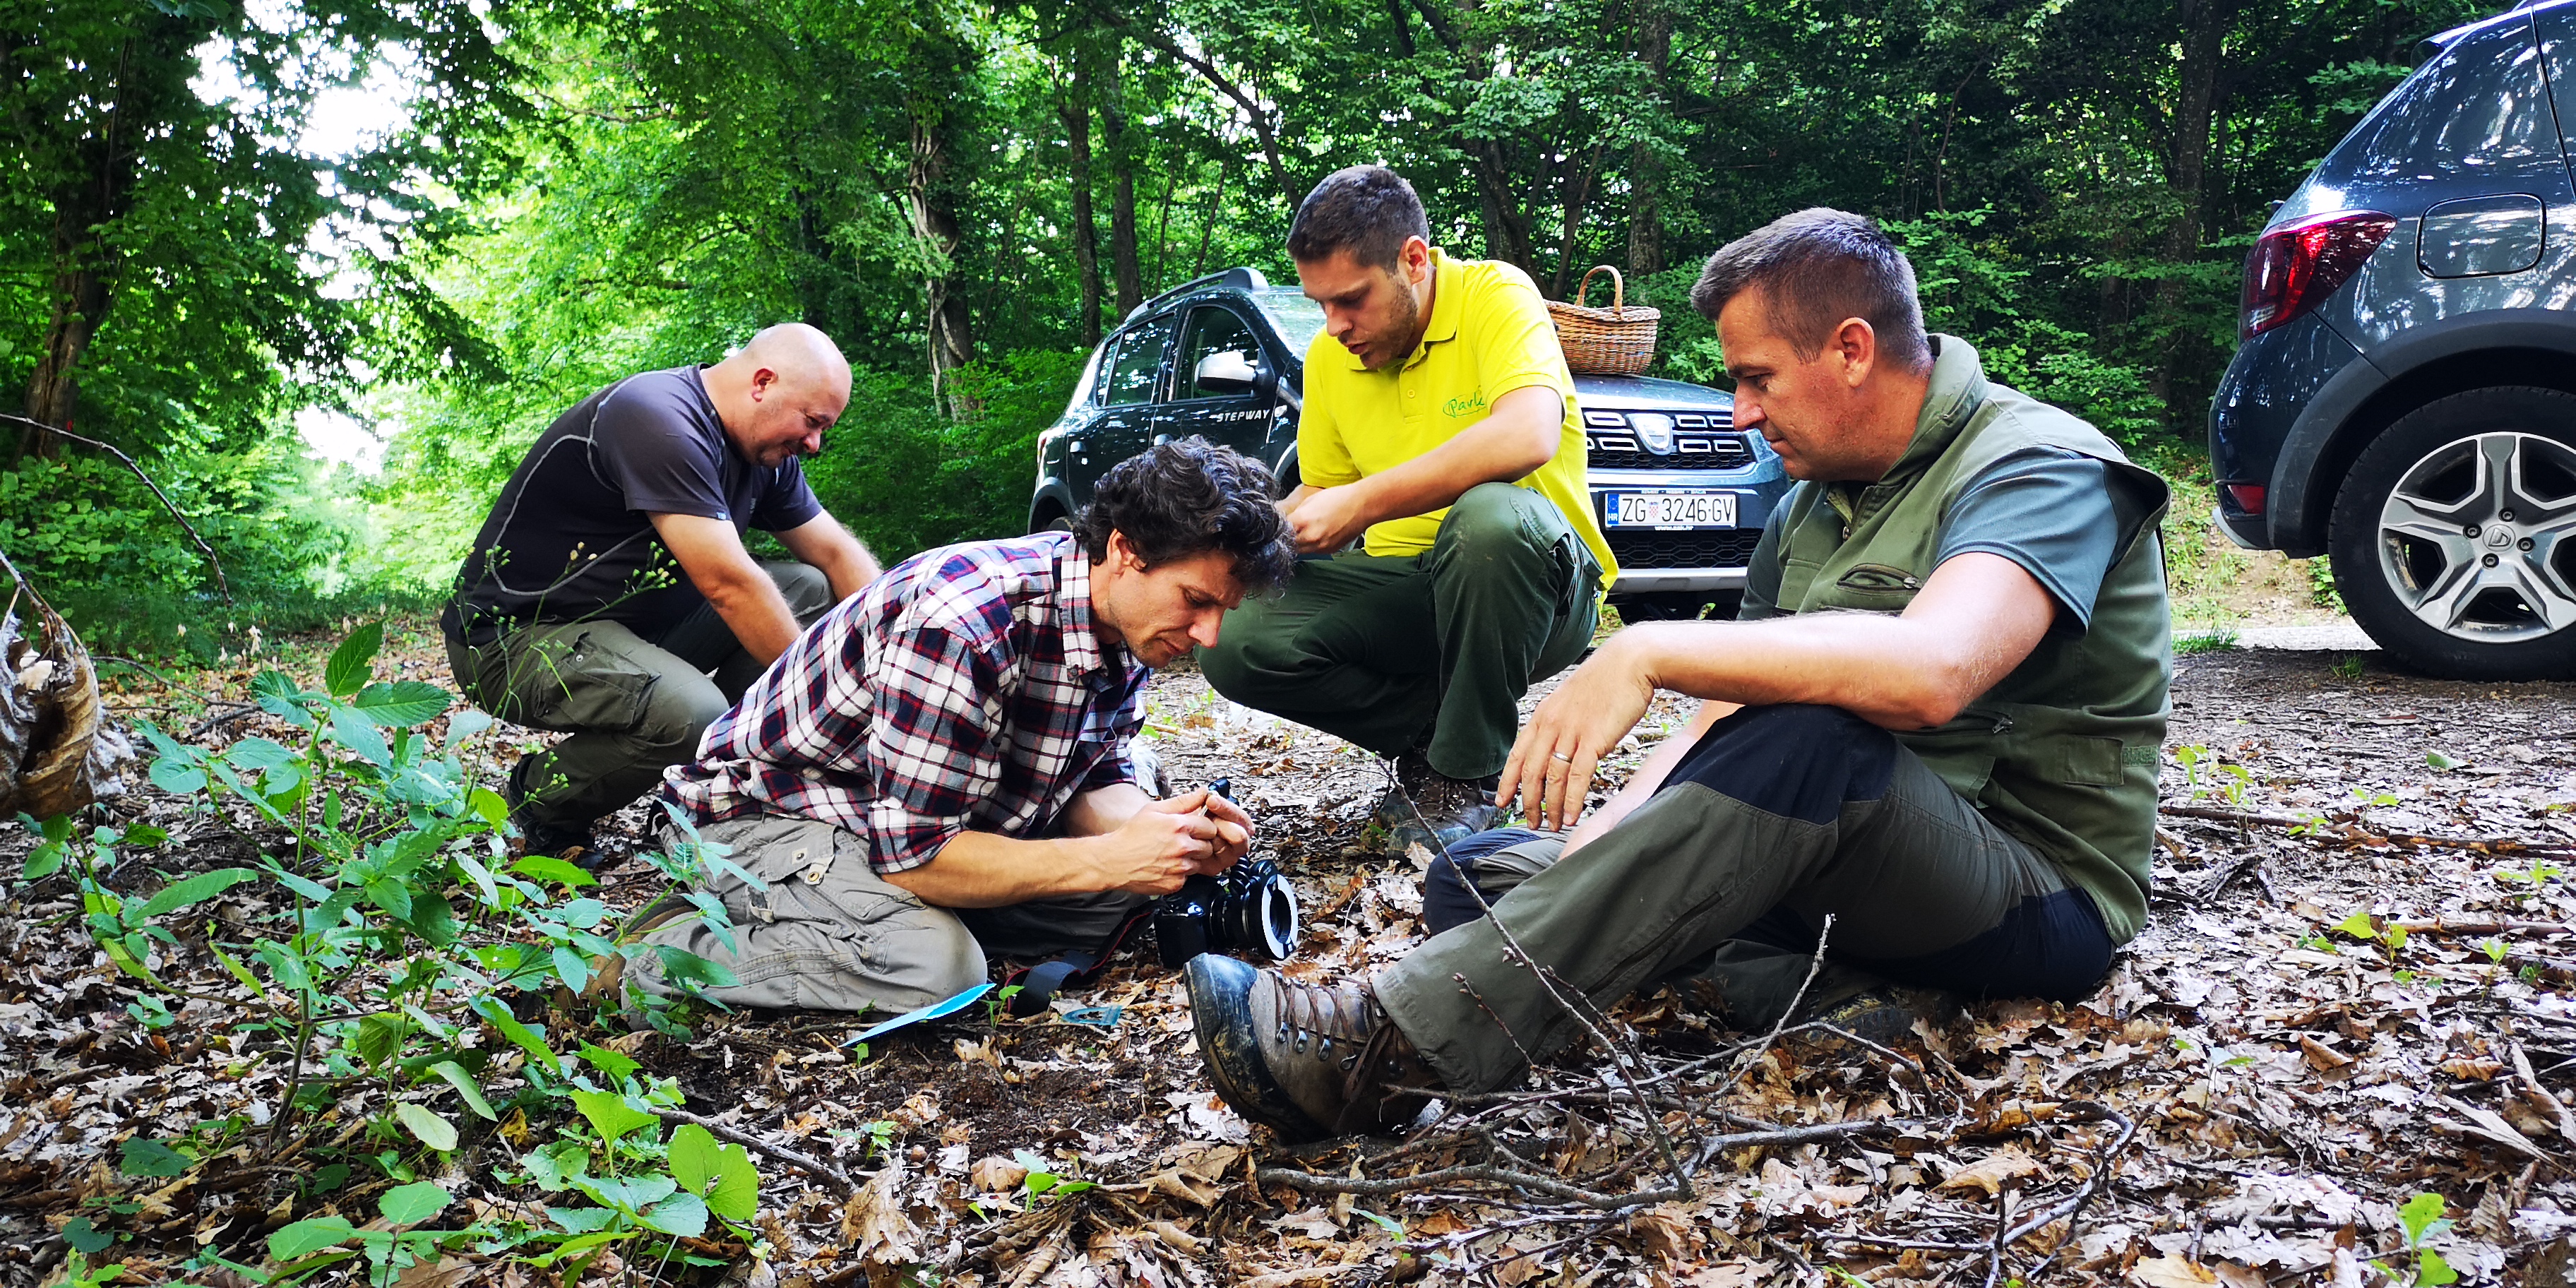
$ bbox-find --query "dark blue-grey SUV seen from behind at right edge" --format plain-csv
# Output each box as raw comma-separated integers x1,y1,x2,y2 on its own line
2210,0,2576,680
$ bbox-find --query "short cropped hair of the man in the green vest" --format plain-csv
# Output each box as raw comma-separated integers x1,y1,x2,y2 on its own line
1690,206,1932,371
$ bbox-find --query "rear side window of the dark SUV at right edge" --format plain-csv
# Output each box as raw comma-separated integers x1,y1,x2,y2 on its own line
2316,18,2558,186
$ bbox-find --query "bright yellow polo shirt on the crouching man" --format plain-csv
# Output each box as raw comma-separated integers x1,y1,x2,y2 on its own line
1296,247,1618,588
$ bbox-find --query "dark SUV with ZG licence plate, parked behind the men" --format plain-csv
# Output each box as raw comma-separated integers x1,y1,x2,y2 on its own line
1028,268,1788,621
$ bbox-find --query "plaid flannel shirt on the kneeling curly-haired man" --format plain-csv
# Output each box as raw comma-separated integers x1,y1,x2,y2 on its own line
662,533,1152,873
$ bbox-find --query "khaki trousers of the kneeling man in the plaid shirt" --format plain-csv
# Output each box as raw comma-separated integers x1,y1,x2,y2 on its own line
628,814,1146,1013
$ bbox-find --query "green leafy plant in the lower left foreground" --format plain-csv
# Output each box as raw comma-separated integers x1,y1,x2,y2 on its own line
20,624,758,1283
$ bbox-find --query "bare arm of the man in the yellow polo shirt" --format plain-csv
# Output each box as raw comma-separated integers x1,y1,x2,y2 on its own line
1280,384,1566,554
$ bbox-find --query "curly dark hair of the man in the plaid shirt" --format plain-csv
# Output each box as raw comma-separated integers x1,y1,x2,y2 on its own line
1074,436,1296,590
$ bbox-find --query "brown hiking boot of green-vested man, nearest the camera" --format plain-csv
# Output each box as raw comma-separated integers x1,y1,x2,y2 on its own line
1185,953,1440,1141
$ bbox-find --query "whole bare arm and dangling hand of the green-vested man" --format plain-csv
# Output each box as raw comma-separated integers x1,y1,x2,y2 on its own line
1494,551,2056,827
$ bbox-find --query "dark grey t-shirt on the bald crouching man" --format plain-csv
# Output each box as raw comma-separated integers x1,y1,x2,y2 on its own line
438,366,822,647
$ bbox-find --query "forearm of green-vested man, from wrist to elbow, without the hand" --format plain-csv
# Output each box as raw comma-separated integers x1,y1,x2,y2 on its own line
1602,613,2009,729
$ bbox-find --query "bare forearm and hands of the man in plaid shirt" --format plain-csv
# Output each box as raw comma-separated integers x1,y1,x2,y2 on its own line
886,783,1252,907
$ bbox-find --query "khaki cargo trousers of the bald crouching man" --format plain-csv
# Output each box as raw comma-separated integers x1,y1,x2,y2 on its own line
448,561,832,830
